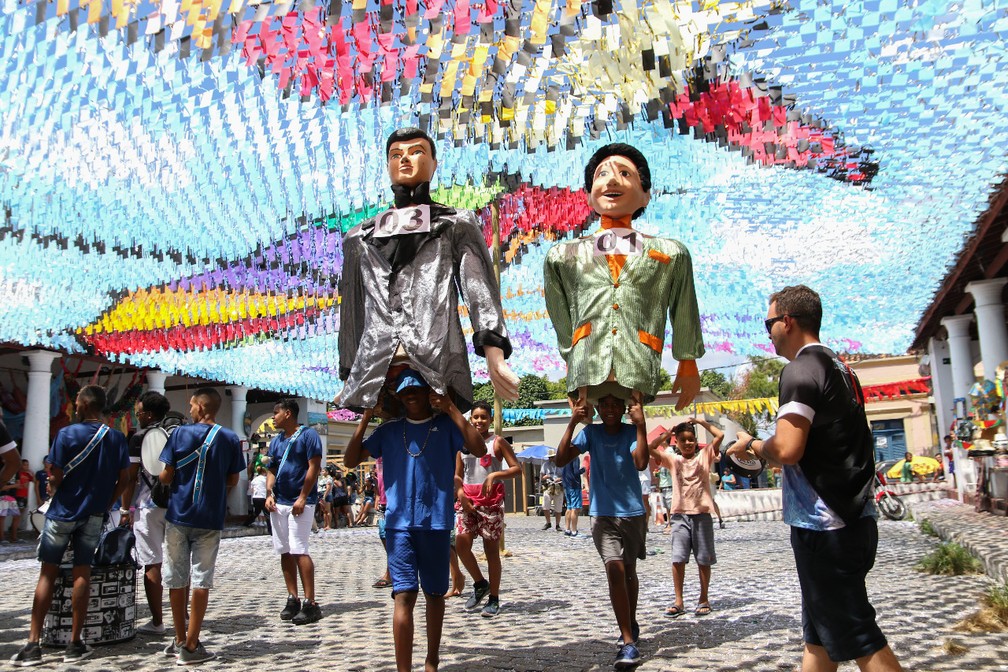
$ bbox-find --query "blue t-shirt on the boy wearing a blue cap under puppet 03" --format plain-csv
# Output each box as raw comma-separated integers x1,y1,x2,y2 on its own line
364,414,464,530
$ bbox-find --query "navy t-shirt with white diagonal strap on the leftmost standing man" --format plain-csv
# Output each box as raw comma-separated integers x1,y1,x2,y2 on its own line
45,422,129,522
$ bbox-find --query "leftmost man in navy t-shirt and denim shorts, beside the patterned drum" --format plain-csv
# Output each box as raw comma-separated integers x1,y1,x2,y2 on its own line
11,385,129,667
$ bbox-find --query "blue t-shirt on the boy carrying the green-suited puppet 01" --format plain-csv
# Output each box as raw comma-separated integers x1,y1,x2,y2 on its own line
572,422,644,518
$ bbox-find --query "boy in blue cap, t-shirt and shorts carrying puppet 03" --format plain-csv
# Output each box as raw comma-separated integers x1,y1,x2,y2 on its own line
343,369,487,672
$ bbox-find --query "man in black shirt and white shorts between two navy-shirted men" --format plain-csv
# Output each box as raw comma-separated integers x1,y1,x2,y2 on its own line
119,392,181,635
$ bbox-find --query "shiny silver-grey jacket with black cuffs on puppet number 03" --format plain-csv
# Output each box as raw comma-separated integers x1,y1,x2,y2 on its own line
336,204,511,412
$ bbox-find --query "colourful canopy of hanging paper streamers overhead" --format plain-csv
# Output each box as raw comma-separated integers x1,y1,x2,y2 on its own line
0,0,1008,399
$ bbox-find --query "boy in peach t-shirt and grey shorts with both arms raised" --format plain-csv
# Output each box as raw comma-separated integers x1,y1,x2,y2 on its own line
651,418,725,618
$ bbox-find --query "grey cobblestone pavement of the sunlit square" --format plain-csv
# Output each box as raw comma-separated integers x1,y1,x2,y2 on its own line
0,509,1008,672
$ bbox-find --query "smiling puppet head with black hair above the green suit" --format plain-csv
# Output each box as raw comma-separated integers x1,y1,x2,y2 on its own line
585,142,651,220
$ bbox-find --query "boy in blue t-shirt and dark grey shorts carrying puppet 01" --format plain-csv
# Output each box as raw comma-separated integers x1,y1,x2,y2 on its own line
556,395,648,670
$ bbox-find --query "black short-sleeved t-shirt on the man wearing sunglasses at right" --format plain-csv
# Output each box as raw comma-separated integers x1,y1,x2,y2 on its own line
777,345,875,525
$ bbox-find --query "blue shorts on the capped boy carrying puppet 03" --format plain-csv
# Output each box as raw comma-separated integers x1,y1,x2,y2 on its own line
385,529,452,597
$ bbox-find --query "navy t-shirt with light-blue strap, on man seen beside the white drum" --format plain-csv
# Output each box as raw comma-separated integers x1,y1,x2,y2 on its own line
160,422,245,530
